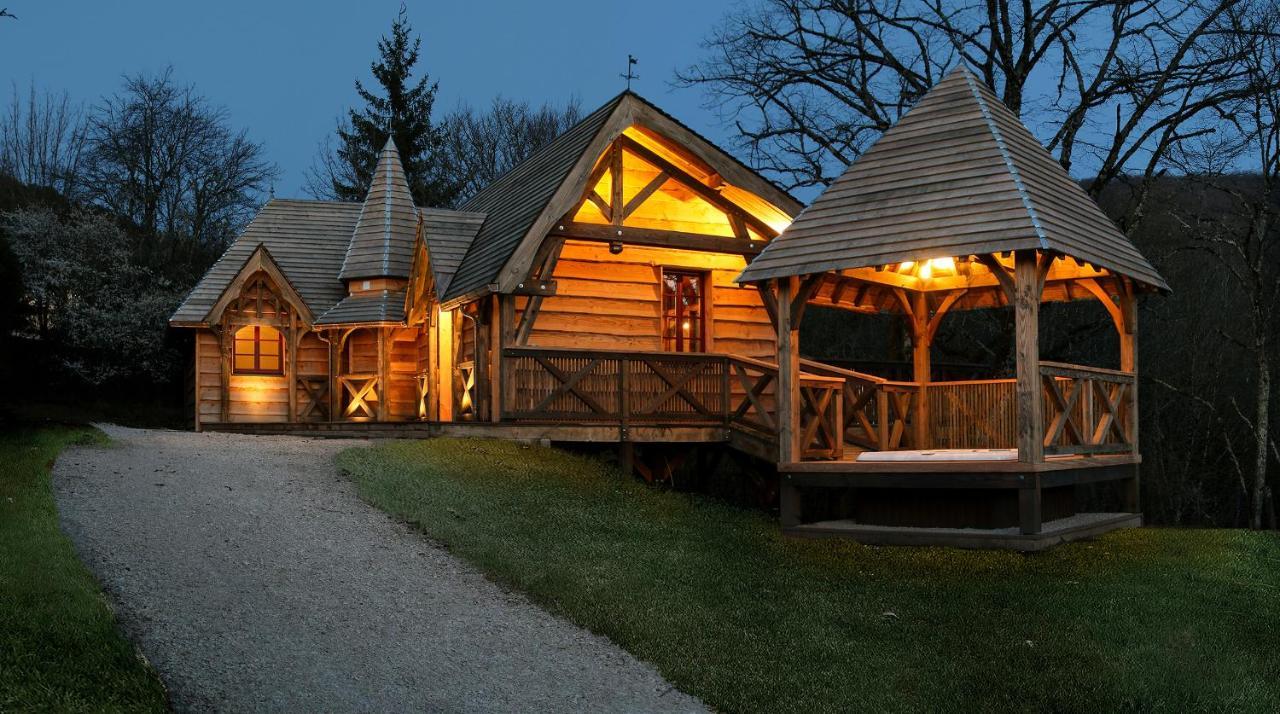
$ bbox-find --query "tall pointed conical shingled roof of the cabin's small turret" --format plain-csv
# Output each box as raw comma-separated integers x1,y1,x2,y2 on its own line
339,138,417,280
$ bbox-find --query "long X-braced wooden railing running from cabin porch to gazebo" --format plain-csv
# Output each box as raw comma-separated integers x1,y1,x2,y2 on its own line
502,347,844,458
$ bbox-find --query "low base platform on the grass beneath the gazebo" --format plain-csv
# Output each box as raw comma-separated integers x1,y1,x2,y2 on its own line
786,513,1142,551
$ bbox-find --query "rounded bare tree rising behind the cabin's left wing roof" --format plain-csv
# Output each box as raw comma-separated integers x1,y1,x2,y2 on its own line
83,70,278,277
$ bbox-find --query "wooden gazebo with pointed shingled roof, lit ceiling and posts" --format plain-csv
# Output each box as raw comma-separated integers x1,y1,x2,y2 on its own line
739,65,1169,463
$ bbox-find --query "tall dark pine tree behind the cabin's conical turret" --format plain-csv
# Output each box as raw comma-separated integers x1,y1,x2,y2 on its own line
308,4,457,206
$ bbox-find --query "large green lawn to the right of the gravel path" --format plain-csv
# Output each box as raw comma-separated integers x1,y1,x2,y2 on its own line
339,439,1280,711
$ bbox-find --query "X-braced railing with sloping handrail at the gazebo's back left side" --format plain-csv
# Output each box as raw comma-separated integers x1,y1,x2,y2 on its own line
800,360,920,452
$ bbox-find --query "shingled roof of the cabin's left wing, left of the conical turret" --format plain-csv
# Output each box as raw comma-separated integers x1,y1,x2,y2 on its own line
169,198,360,326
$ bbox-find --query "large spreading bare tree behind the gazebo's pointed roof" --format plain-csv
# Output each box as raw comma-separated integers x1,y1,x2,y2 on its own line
678,0,1265,218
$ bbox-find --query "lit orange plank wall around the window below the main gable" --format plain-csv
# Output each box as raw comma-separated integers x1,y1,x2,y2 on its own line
514,241,777,361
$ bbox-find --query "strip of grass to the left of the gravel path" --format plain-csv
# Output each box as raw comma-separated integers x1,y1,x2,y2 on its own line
0,427,166,711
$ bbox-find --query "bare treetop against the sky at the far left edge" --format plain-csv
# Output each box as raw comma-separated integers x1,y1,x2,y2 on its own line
0,83,84,197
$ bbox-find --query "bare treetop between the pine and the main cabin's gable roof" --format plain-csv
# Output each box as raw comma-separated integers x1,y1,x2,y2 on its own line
443,96,582,203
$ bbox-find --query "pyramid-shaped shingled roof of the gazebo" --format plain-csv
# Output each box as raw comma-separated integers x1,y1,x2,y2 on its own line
739,65,1169,290
